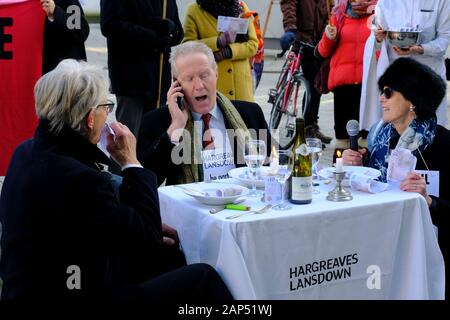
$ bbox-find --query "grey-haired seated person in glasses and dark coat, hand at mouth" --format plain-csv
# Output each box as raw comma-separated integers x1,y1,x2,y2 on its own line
0,60,230,299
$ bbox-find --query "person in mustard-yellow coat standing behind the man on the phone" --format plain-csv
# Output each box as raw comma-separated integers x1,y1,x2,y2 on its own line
183,0,258,102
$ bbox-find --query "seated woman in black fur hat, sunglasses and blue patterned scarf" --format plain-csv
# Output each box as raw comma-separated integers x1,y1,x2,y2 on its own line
343,58,450,296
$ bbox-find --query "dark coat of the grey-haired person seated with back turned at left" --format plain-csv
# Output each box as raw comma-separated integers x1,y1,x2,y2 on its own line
0,122,162,299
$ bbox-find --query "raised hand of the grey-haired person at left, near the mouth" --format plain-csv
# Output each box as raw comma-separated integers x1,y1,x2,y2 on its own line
106,122,139,167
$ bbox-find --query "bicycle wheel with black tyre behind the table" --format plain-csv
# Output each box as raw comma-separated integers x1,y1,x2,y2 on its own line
271,75,310,150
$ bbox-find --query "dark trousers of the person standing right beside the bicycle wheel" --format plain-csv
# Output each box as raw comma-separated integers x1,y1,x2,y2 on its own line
301,48,322,126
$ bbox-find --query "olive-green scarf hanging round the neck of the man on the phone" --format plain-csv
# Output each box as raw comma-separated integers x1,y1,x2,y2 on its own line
178,92,252,184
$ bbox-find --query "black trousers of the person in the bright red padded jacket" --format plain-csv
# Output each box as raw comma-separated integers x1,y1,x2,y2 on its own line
333,84,361,139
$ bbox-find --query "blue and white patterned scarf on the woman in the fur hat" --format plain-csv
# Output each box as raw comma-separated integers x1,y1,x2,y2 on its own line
369,117,437,182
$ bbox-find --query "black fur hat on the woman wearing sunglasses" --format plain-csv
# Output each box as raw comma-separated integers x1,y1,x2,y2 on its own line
378,58,446,119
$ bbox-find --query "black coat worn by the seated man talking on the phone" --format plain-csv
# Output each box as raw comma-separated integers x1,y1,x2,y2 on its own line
138,101,271,185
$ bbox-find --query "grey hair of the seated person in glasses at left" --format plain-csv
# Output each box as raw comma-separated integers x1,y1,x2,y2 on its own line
34,59,109,134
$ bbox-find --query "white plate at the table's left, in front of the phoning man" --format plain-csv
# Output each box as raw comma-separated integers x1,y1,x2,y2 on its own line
180,182,250,206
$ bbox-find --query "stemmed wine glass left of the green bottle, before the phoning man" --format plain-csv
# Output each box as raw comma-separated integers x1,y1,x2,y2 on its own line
244,140,267,197
